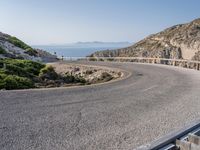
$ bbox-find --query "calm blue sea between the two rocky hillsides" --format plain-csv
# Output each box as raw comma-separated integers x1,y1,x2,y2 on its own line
33,46,119,57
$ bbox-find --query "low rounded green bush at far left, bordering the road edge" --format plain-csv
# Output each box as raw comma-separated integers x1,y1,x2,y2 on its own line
1,75,34,90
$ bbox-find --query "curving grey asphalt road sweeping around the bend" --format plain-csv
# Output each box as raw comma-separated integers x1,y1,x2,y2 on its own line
0,62,200,150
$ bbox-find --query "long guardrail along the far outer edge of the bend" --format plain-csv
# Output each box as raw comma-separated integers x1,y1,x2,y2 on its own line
60,57,200,70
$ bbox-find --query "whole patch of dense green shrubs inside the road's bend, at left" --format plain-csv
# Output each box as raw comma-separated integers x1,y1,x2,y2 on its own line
0,58,86,90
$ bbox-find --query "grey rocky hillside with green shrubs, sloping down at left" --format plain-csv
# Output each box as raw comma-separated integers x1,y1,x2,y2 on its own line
0,32,57,62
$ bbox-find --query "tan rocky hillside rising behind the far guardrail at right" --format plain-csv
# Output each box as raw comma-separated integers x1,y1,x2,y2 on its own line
91,19,200,60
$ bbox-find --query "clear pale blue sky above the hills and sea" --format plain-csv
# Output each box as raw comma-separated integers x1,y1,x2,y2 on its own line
0,0,200,45
